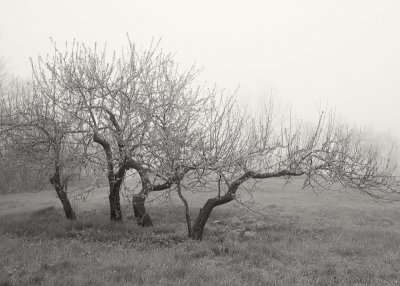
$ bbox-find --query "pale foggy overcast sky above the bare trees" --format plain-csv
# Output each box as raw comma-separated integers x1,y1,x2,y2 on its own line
0,0,400,140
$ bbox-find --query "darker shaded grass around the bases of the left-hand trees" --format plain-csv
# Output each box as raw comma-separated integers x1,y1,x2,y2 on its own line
0,207,203,250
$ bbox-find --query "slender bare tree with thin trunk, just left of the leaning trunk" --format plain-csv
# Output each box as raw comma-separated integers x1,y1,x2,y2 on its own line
145,91,243,237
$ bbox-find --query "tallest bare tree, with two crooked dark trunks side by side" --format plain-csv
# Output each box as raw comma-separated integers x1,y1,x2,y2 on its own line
33,39,211,222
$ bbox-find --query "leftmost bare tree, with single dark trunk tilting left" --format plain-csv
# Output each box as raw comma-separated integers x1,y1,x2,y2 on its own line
0,78,85,219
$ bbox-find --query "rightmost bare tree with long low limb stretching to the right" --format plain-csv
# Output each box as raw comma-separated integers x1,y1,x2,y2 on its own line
158,101,399,240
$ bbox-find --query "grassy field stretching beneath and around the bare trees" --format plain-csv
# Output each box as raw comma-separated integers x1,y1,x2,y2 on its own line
0,180,400,286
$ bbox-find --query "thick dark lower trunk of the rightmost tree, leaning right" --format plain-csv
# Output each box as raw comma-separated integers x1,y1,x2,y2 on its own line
191,196,233,240
